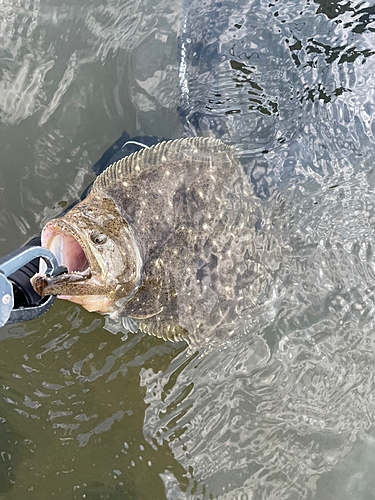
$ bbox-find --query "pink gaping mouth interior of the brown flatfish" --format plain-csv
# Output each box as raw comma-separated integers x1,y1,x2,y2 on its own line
39,224,91,279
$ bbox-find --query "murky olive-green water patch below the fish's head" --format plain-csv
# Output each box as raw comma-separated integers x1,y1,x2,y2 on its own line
1,304,191,499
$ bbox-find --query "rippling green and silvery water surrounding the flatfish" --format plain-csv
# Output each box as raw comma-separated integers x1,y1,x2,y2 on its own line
0,0,375,500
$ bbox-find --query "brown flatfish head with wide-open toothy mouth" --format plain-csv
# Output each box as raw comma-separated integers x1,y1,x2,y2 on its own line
31,190,140,313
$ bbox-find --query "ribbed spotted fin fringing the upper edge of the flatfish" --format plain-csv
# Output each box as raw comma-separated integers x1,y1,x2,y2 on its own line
93,137,234,189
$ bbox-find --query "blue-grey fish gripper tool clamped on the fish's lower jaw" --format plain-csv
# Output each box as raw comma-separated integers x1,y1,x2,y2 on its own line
0,246,67,327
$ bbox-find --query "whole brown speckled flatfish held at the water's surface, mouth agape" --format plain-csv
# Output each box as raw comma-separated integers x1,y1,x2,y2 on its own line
31,137,265,341
